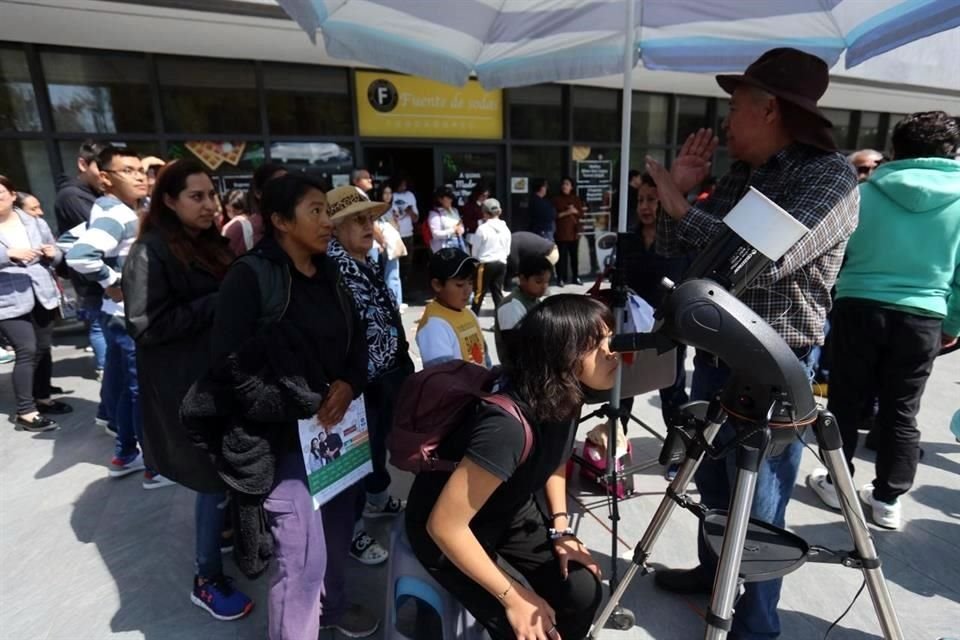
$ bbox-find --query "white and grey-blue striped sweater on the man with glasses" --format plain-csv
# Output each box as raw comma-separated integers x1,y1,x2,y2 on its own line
67,196,140,317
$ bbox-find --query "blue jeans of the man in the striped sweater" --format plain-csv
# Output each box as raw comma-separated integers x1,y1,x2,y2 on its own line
100,314,143,458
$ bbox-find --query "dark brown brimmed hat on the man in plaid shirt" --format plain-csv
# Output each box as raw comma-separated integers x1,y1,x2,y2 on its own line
717,47,837,151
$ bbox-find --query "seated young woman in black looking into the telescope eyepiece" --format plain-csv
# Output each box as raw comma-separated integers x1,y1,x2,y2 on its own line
406,295,617,640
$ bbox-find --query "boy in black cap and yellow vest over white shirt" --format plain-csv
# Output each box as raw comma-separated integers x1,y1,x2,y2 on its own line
417,248,490,368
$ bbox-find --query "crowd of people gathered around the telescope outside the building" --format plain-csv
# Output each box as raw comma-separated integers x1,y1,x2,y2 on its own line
0,49,960,640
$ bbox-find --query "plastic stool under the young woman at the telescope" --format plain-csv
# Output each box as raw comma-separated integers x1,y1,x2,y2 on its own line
384,516,489,640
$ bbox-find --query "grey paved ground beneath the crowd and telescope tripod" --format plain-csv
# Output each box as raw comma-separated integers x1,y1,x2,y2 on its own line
0,288,960,640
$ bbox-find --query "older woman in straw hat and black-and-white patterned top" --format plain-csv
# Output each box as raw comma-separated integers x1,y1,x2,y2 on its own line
327,187,413,565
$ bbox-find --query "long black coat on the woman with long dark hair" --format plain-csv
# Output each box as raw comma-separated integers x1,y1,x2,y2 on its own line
121,232,226,493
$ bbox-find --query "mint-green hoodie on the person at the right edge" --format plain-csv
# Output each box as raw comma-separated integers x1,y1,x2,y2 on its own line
836,158,960,336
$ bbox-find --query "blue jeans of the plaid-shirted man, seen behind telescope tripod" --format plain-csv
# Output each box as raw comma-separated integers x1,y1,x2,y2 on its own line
690,349,813,640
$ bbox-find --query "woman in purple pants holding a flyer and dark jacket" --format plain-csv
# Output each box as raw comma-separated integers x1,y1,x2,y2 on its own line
213,174,379,640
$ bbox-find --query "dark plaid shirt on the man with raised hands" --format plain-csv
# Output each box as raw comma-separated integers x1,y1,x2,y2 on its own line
657,144,860,348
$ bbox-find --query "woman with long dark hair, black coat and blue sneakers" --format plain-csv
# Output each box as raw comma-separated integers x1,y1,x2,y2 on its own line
121,160,253,620
